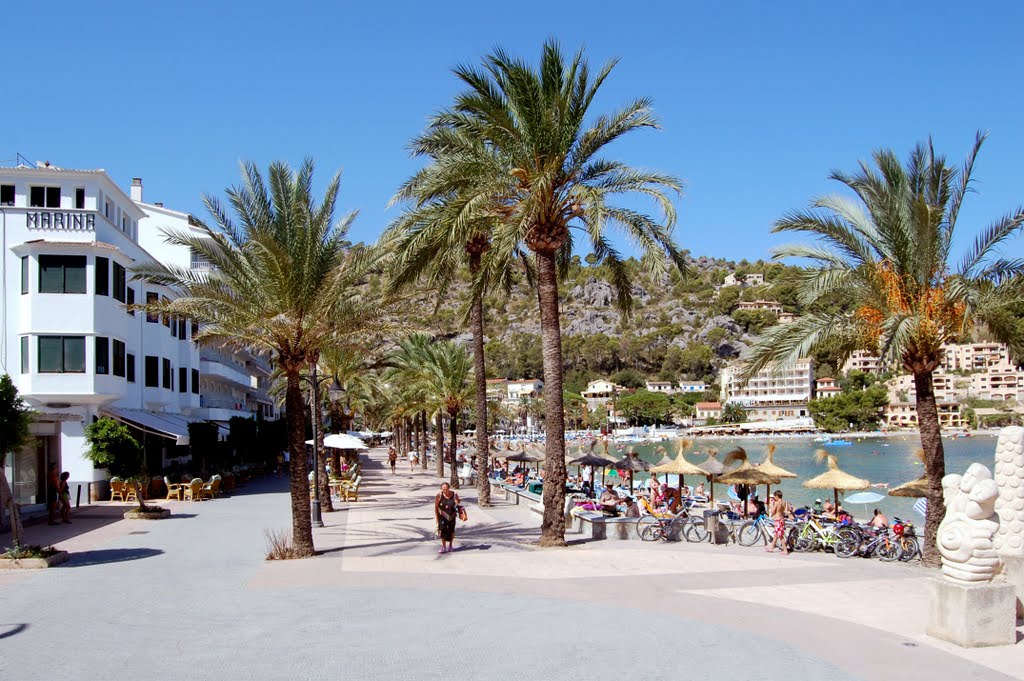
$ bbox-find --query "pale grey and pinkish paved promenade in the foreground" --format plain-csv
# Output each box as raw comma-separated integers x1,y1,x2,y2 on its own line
0,451,1024,681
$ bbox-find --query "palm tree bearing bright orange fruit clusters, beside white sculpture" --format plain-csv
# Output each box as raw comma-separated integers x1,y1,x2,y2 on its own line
744,133,1024,566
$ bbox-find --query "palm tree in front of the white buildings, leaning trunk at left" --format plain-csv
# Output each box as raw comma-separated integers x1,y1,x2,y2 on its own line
134,160,379,555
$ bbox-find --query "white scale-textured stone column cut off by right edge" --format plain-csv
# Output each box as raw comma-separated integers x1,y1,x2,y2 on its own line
992,426,1024,557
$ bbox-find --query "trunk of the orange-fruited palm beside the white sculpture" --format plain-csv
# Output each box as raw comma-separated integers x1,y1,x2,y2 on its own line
913,371,946,567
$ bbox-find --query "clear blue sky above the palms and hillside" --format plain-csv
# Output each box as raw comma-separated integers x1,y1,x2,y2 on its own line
8,0,1024,260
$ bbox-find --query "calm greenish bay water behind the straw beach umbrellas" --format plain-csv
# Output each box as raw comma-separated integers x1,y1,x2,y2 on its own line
593,433,996,526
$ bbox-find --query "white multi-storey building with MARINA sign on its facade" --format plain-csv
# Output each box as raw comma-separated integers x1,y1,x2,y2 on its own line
0,161,200,507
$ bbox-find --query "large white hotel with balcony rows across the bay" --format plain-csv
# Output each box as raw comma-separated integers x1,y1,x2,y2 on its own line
721,357,814,421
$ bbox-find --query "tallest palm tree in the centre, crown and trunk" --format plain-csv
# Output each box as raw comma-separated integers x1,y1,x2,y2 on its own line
403,41,683,546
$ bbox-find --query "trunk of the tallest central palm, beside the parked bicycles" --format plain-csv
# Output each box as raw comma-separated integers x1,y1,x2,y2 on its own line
537,251,565,546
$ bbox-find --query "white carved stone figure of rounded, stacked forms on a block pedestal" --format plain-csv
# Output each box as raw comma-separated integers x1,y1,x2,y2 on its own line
936,464,1000,585
